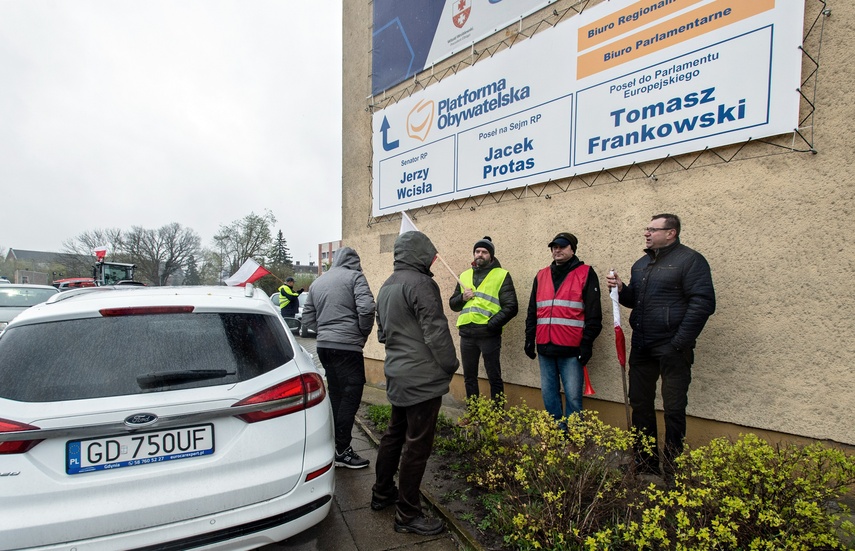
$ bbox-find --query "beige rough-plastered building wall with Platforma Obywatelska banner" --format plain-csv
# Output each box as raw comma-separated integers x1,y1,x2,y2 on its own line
342,0,855,445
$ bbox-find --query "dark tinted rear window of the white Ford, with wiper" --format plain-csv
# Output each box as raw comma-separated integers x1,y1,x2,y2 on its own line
0,313,294,402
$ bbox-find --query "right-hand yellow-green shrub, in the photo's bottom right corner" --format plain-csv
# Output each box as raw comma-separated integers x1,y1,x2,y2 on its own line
586,434,855,551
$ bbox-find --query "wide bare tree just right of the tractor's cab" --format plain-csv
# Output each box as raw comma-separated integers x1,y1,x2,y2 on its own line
124,222,202,285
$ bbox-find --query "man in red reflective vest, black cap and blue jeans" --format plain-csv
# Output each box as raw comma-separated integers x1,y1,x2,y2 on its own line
525,232,603,426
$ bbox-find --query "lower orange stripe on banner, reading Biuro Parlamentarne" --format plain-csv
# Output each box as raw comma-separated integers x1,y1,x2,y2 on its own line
576,0,775,79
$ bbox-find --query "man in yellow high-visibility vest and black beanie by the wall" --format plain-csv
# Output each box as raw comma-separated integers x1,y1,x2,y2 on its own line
448,236,519,400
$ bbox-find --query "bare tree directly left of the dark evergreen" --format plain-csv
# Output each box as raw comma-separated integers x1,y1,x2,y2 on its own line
214,210,276,274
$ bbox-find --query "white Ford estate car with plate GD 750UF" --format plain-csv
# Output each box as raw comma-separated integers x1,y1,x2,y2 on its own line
0,285,335,551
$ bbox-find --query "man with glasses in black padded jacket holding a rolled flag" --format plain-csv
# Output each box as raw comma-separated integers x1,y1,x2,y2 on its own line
607,214,715,477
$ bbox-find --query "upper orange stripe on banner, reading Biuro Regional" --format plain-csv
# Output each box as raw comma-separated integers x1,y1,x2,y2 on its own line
578,0,703,52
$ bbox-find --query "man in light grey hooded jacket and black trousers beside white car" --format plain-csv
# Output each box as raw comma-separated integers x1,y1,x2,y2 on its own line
303,247,375,469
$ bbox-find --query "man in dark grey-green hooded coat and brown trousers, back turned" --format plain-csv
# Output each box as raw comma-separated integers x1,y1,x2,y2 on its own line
371,231,460,535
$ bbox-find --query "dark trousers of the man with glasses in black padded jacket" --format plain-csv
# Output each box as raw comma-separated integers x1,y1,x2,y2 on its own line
629,344,694,473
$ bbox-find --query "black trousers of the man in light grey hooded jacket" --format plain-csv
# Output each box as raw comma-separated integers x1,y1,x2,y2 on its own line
317,347,365,453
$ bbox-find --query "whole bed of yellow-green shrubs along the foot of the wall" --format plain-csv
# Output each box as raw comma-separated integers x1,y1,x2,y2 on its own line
438,398,855,551
